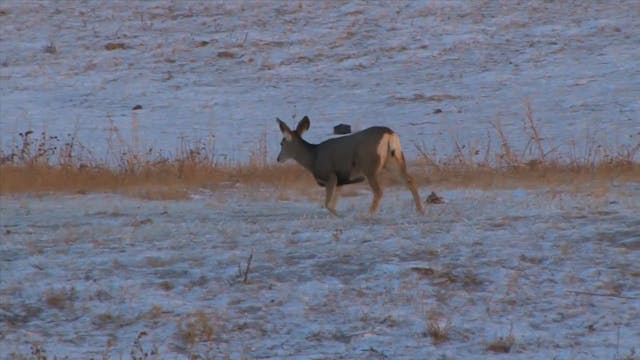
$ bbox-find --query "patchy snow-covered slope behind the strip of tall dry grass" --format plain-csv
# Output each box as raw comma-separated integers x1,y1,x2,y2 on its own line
0,0,640,160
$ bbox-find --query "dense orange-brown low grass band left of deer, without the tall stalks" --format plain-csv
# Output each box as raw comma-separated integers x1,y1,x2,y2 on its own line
0,160,312,194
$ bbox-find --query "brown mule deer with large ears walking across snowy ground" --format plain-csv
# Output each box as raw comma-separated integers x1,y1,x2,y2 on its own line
276,116,424,216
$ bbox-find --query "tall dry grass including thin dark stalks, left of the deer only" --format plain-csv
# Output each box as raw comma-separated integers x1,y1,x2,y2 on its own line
0,127,310,198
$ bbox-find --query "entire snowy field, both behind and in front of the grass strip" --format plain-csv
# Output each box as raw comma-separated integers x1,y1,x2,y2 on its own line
0,0,640,360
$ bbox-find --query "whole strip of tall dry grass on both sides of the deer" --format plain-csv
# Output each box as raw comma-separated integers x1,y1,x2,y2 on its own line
0,106,640,199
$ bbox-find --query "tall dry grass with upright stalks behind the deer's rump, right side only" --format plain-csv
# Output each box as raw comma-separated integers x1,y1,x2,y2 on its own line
412,100,640,188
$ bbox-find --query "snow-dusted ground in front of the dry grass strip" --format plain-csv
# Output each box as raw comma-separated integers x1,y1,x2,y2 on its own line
0,184,640,359
